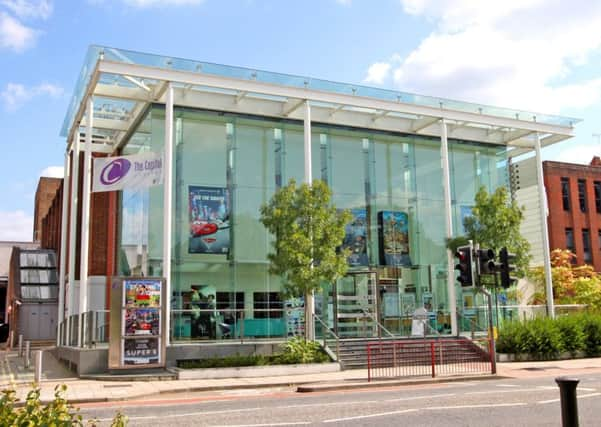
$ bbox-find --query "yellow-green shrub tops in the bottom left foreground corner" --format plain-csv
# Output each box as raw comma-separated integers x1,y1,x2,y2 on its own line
0,384,128,427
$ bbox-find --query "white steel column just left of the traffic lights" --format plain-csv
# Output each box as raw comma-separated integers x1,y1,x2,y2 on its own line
440,119,459,336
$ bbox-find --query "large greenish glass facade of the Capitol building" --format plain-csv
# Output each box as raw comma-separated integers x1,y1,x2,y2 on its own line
118,106,508,341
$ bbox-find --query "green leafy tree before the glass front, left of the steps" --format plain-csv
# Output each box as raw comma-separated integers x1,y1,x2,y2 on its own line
261,180,351,333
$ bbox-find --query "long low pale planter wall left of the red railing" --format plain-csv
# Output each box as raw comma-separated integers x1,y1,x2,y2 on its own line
173,363,340,380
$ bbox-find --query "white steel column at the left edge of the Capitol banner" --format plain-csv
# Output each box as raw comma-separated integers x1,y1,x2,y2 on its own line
77,97,94,347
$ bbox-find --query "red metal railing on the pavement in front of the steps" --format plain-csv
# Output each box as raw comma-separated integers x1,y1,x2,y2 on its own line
367,338,496,381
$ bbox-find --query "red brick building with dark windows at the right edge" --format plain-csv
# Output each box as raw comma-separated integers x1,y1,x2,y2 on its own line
543,157,601,271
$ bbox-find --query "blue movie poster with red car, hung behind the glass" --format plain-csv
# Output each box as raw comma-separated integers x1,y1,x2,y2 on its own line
188,186,230,254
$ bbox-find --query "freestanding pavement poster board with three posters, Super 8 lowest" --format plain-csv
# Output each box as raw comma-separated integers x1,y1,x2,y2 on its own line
109,277,165,369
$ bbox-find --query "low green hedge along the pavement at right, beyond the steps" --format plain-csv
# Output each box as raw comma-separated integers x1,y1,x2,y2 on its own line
497,314,601,360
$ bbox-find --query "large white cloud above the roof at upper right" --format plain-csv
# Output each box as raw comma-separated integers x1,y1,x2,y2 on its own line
366,0,601,113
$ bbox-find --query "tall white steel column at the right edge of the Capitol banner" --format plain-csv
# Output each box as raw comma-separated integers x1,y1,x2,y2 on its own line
163,83,173,345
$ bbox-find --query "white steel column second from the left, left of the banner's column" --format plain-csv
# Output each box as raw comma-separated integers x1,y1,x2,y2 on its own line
67,135,79,345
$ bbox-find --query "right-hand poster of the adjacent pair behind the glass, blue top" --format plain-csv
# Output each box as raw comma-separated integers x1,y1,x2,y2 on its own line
378,211,411,267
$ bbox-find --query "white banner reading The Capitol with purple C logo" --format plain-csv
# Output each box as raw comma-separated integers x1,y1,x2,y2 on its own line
92,152,163,192
